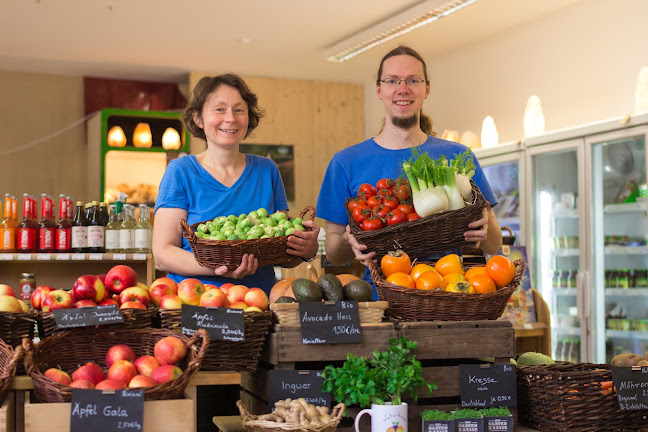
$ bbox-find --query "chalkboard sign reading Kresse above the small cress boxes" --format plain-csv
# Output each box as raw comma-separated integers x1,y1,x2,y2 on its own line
459,364,517,409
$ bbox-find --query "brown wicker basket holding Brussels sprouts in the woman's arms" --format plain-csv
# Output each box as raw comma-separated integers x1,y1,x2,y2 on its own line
180,206,315,270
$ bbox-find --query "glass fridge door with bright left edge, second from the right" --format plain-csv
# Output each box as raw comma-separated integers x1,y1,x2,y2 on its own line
527,139,587,363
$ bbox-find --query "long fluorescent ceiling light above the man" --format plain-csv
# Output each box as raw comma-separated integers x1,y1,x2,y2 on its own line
324,0,477,62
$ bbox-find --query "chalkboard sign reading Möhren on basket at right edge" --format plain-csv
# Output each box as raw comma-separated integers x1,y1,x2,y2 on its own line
612,366,648,410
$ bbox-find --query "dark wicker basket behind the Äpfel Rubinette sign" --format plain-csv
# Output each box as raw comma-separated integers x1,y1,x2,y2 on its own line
159,309,272,372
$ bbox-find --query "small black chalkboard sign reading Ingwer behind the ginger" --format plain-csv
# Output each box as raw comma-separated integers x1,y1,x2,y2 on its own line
268,369,331,408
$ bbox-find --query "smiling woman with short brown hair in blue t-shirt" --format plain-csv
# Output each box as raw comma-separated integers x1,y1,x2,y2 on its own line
153,74,319,293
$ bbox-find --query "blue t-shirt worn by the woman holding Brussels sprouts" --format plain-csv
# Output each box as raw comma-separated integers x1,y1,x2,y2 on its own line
155,154,288,293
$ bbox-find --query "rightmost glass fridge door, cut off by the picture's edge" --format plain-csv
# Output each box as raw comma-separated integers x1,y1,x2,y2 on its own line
586,127,648,363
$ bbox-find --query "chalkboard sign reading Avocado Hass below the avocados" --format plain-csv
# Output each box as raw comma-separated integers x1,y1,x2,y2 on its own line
299,301,362,344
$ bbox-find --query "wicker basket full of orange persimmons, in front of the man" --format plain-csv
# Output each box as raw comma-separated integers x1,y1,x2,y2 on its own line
369,250,525,321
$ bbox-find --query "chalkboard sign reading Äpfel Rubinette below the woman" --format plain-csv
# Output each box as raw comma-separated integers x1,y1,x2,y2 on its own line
181,304,245,342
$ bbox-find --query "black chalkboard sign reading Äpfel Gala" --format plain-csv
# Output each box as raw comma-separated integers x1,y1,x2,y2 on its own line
70,388,144,432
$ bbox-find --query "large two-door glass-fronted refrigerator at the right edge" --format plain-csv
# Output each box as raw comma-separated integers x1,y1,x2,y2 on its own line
523,114,648,363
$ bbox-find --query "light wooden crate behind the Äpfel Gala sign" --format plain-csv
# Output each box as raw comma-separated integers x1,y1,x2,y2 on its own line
25,393,196,432
